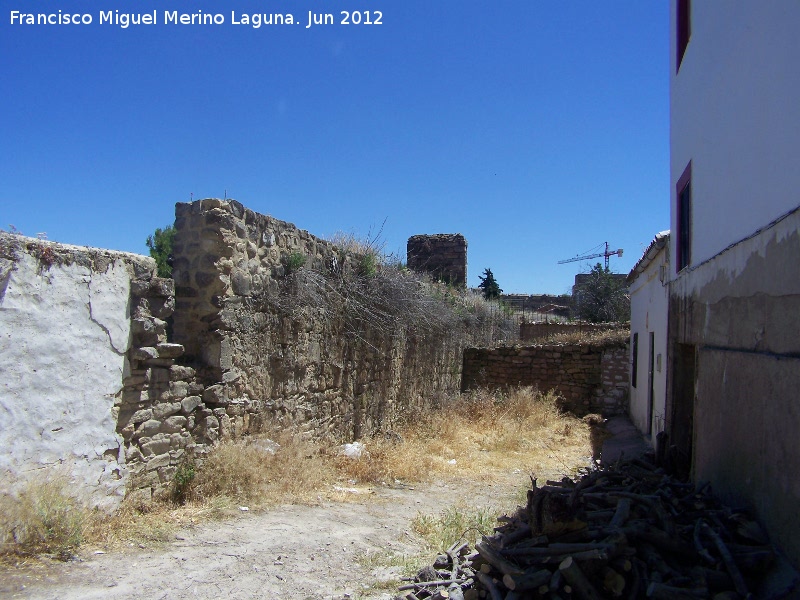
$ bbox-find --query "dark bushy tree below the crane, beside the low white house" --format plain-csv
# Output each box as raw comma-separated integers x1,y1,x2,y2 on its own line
575,263,631,323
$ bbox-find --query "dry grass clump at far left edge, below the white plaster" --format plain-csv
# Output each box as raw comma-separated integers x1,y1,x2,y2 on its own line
0,474,93,559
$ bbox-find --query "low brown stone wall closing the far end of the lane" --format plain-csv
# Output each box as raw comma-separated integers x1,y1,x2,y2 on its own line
461,345,629,415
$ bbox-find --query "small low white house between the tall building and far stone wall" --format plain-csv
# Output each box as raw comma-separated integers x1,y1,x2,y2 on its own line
627,231,669,447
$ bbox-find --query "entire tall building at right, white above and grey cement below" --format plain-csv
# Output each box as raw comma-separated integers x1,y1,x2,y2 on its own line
666,0,800,565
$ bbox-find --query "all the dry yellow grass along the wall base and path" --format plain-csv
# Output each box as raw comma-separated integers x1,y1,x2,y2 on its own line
0,389,591,557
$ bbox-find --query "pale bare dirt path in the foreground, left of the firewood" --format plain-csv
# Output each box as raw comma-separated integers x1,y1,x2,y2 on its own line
0,473,526,600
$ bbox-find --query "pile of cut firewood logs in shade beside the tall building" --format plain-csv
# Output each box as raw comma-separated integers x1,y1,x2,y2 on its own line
397,459,796,600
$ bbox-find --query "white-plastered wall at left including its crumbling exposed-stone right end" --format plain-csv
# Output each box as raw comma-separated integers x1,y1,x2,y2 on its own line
0,233,222,508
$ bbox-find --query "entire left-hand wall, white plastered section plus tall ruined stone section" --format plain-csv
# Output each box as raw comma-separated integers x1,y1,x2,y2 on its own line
0,200,505,507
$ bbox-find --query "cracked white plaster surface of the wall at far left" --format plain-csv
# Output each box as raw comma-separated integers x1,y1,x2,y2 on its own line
0,234,154,506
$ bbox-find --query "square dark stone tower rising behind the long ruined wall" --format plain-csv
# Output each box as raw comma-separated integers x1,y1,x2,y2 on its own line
406,233,467,287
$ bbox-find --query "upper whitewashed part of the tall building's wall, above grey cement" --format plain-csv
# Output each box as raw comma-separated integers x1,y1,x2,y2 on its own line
670,0,800,265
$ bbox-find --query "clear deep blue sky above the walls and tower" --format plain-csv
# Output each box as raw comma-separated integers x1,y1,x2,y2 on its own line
0,0,669,294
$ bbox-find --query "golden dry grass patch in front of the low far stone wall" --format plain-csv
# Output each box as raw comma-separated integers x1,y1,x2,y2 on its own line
337,388,592,483
